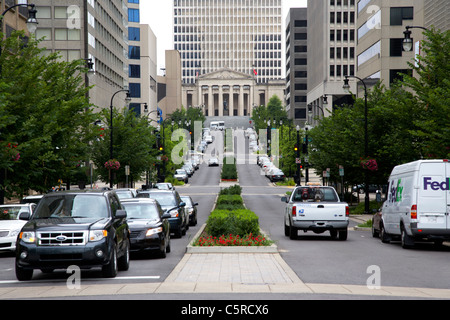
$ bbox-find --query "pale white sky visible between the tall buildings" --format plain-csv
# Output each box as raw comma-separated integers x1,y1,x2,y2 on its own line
139,0,307,74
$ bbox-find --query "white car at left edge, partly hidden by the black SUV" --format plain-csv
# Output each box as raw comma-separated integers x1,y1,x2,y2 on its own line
0,203,36,252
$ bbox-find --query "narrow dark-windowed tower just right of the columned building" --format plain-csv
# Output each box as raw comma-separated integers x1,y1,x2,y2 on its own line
285,8,308,125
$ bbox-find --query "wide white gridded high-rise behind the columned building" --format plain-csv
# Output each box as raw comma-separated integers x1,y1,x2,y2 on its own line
173,0,282,84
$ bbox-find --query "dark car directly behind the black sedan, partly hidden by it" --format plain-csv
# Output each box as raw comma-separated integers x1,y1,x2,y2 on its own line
137,189,189,238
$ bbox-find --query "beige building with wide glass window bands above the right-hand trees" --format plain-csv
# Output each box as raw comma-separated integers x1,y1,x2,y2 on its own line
355,0,424,91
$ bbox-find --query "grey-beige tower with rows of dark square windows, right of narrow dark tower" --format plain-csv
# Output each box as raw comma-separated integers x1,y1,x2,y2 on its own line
307,0,356,124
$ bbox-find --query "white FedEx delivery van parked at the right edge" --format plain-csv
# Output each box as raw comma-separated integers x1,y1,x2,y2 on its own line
380,160,450,248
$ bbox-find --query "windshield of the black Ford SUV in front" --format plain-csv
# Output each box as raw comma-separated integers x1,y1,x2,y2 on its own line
33,194,108,219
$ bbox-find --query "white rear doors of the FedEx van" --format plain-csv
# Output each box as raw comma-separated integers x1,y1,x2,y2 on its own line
413,161,450,229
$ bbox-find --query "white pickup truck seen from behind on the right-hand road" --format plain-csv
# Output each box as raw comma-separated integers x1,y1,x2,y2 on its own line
281,186,349,240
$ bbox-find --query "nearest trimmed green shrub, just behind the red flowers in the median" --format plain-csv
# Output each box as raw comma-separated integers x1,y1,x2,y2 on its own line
206,209,259,237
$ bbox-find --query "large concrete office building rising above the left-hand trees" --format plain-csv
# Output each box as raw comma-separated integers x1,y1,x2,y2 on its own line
36,0,128,108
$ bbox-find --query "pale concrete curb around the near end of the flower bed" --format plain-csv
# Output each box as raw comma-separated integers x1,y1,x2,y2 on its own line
186,223,278,254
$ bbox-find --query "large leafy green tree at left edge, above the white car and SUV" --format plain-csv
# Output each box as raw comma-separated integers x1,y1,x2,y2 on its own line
0,31,93,200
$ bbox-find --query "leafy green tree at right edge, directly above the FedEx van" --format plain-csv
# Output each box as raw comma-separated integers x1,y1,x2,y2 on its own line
403,28,450,159
